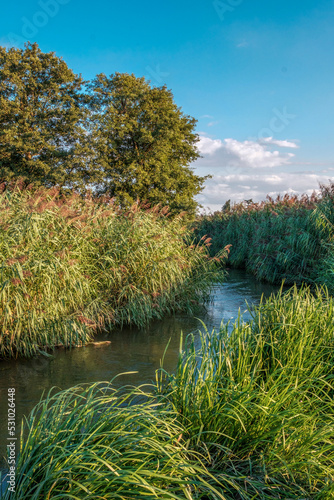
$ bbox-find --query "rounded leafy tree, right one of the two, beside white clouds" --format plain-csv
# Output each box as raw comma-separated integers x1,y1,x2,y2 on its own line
90,73,206,213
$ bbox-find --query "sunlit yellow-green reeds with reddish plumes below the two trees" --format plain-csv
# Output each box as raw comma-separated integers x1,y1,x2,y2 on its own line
0,184,226,358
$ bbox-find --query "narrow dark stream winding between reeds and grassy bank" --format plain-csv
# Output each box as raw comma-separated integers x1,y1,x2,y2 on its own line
0,270,278,470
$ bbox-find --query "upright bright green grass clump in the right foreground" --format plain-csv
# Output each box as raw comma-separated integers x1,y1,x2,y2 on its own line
162,287,334,500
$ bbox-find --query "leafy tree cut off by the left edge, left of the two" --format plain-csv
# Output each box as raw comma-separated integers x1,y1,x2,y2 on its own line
0,43,91,187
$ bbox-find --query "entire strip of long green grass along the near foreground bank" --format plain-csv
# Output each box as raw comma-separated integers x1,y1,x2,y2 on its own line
3,287,334,500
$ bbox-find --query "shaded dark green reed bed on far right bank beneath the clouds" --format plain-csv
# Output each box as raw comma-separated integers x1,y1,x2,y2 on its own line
195,184,334,289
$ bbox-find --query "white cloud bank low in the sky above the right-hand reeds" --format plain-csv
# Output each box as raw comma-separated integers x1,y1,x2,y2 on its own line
194,136,334,210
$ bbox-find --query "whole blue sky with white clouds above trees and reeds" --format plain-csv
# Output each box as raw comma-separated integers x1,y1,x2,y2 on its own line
0,0,334,210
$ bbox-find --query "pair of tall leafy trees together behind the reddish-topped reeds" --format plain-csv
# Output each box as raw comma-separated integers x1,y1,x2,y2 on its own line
0,43,206,213
